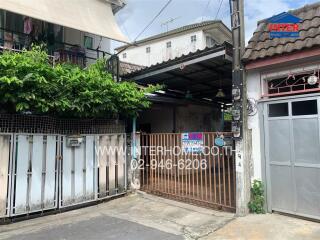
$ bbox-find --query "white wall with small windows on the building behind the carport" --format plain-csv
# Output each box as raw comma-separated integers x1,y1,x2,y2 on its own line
119,30,215,66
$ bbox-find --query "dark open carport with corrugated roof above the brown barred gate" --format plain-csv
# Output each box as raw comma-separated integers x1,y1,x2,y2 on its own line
124,43,232,133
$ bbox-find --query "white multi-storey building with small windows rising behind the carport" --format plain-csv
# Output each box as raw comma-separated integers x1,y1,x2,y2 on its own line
116,21,232,66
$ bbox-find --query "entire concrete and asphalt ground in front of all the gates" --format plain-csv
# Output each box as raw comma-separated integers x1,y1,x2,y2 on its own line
0,193,320,240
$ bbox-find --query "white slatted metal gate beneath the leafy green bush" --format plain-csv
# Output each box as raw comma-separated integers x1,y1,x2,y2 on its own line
0,134,127,218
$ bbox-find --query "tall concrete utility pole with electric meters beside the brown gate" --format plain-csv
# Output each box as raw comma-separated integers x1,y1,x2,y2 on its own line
229,0,251,216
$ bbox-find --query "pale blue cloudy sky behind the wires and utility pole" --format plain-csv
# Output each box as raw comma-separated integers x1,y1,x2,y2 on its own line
112,0,319,50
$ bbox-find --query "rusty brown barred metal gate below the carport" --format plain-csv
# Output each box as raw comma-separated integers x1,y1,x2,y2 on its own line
138,133,235,211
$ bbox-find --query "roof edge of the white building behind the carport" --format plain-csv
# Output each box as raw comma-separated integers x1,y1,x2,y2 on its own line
116,20,231,50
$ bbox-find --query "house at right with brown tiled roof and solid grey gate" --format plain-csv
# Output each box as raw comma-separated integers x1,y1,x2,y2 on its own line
243,3,320,219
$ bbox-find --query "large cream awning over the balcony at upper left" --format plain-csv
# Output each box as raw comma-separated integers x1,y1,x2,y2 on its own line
0,0,129,43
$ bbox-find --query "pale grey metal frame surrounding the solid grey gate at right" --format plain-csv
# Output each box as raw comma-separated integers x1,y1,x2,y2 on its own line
258,93,320,220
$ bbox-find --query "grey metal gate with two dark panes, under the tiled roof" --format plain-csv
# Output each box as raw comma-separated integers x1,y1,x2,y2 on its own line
264,97,320,219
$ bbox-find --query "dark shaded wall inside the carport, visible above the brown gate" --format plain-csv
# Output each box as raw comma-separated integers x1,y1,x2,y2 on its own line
138,104,221,133
